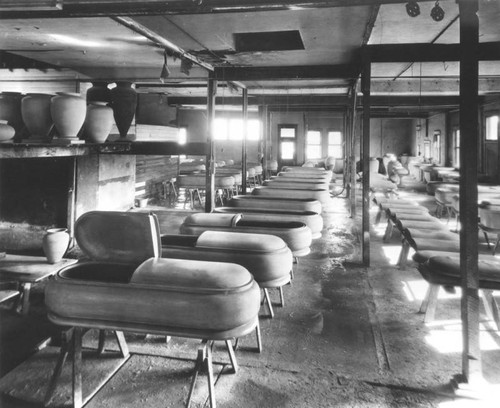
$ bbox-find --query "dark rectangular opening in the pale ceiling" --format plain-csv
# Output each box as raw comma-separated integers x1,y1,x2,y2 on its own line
233,30,304,52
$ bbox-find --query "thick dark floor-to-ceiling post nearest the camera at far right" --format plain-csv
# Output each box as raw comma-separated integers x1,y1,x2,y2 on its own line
458,0,482,382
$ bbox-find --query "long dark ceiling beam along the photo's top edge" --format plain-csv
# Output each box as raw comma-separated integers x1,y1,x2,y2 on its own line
0,0,434,19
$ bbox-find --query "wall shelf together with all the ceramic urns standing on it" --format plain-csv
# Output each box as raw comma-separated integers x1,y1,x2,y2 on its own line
0,86,207,159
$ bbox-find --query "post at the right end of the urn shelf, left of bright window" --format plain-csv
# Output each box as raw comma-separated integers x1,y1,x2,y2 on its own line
205,78,217,213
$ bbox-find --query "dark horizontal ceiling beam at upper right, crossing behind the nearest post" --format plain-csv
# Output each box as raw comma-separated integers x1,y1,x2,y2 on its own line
362,41,500,62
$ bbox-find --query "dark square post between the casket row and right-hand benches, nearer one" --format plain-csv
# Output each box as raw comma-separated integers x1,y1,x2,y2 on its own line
361,59,371,266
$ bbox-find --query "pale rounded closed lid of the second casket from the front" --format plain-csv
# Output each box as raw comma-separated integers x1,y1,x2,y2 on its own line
196,231,286,252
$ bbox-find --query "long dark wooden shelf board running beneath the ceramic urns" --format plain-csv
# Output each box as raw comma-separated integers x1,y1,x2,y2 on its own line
0,142,207,159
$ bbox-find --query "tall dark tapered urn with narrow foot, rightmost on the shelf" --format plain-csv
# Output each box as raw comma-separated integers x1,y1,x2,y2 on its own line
111,82,137,140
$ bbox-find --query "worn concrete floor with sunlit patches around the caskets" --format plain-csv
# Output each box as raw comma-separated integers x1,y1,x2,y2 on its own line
0,183,500,408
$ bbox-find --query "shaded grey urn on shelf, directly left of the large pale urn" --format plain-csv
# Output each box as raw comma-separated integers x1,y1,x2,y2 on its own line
21,93,54,142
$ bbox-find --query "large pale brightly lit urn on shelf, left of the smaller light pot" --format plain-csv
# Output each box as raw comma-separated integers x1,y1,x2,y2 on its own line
50,92,87,139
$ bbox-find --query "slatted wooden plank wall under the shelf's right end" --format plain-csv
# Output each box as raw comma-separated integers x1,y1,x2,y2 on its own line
135,156,178,198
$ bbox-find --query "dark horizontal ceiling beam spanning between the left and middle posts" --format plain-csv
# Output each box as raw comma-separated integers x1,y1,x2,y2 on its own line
214,64,359,81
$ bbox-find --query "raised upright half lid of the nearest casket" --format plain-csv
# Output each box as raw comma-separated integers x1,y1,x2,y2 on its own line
75,211,161,264
